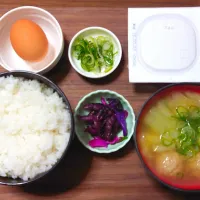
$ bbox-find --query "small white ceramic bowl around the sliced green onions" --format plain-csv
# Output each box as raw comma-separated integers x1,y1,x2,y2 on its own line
68,27,122,78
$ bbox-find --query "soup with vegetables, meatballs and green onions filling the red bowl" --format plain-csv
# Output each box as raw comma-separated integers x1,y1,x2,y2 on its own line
137,90,200,189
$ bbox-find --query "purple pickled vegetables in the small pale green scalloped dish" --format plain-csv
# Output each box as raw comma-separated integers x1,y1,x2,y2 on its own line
79,97,128,148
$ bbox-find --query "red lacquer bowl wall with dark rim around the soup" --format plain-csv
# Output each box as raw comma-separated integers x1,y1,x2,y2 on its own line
134,83,200,192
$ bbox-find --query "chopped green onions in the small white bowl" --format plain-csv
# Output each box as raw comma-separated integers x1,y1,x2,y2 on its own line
73,36,117,73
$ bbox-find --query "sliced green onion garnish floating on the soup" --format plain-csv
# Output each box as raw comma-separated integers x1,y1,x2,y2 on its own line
160,106,200,157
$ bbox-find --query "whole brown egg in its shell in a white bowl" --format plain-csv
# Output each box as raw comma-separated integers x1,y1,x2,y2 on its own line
10,19,48,62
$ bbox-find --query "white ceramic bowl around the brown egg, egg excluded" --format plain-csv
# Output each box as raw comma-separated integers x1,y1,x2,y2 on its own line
0,6,64,74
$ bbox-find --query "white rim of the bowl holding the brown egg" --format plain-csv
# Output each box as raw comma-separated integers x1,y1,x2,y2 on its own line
0,6,64,74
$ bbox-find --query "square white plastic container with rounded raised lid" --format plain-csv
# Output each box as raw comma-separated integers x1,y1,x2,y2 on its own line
128,7,200,83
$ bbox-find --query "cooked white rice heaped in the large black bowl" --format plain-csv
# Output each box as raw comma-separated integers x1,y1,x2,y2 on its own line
0,76,71,180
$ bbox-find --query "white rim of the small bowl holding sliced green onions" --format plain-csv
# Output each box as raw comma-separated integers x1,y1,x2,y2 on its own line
68,26,122,79
